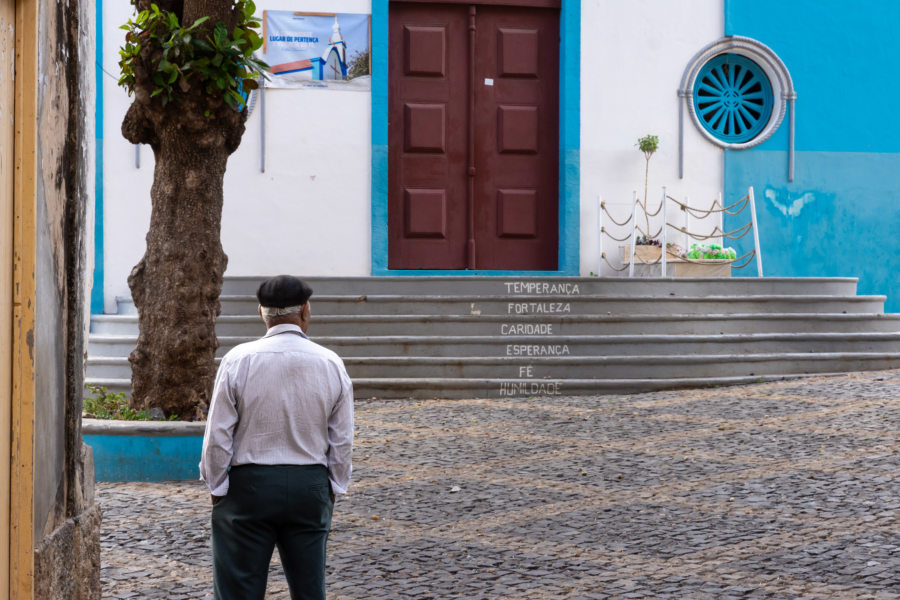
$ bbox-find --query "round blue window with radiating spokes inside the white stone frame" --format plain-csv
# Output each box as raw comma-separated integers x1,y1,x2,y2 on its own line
693,54,775,144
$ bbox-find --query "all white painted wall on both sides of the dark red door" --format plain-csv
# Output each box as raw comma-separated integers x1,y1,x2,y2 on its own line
103,0,723,312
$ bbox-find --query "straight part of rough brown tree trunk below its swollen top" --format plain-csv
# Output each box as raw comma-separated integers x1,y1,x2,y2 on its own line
128,128,228,418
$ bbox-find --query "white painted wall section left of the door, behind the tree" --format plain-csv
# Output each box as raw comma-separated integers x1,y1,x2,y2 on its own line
103,0,372,312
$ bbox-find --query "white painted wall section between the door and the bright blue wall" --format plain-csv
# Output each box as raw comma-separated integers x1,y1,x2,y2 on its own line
581,0,727,275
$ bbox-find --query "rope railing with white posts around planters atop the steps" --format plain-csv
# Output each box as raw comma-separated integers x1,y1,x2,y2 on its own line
597,187,763,277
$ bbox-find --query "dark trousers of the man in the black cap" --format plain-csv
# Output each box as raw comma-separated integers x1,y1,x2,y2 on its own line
212,465,334,600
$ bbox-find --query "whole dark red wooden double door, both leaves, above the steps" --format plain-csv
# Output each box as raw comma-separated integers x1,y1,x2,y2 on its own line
388,3,559,270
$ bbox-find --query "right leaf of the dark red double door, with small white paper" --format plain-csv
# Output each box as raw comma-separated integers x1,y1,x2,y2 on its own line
475,7,559,270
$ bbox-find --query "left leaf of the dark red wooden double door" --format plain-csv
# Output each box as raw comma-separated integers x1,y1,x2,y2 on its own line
388,4,467,269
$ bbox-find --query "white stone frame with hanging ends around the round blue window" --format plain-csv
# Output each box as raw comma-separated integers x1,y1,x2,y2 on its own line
678,35,797,181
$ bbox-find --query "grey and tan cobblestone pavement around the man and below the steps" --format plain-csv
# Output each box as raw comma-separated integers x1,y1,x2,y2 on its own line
98,371,900,600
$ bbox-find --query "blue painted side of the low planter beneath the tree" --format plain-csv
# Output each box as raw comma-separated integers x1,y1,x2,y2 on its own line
84,434,203,481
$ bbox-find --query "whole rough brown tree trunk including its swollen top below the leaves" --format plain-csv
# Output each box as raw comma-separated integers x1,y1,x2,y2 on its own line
122,0,246,419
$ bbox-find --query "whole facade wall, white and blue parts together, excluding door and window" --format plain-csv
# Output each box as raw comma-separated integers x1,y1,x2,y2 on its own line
96,0,900,304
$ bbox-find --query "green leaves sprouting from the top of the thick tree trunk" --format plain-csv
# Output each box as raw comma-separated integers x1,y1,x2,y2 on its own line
119,0,268,110
